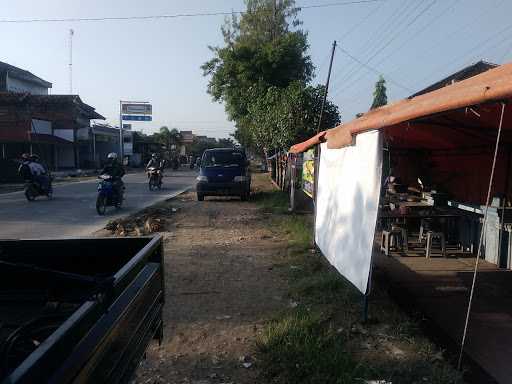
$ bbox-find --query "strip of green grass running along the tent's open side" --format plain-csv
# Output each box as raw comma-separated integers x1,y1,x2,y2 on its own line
256,182,463,384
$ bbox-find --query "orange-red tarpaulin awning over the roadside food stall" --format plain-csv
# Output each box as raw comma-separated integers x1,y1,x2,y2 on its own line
290,63,512,153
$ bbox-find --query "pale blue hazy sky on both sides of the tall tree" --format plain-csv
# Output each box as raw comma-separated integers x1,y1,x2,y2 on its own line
0,0,512,138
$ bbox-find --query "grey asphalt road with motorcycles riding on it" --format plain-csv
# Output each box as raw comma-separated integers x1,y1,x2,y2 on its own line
0,170,196,239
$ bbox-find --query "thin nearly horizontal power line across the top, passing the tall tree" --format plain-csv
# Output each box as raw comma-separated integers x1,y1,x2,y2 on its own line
0,0,388,24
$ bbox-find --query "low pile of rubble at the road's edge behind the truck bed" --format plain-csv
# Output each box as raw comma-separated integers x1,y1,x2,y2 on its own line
105,207,177,236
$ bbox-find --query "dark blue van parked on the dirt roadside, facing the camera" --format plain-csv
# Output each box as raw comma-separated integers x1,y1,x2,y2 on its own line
196,148,251,201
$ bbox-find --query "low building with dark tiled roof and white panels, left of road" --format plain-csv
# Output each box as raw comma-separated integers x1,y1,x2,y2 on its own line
0,92,105,178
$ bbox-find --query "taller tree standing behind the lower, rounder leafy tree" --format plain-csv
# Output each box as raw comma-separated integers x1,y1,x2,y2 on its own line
201,0,313,151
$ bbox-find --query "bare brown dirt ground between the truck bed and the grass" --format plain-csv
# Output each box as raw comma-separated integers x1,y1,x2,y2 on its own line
134,178,290,384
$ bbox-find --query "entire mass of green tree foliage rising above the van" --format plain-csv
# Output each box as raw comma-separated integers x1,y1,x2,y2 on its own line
201,0,339,149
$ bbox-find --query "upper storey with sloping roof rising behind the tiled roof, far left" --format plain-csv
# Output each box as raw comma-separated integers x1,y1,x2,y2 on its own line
0,61,52,95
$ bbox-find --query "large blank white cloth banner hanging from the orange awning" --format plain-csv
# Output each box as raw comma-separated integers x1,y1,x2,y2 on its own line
315,131,382,294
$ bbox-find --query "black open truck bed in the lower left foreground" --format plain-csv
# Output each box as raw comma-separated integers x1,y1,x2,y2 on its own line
0,236,164,384
